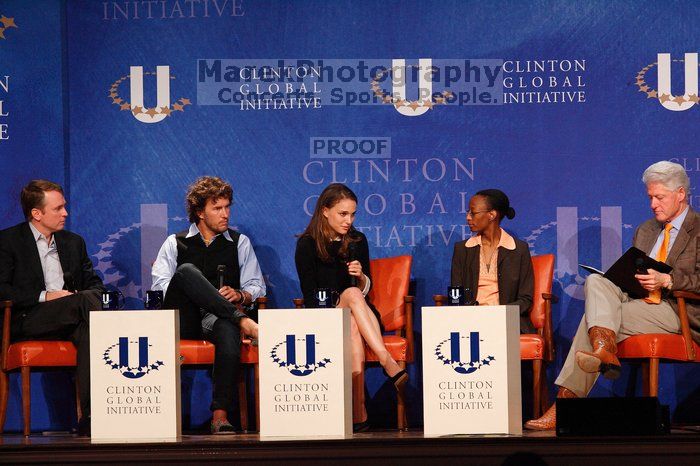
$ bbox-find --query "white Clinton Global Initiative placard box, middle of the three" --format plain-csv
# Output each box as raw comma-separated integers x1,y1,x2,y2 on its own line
259,308,352,437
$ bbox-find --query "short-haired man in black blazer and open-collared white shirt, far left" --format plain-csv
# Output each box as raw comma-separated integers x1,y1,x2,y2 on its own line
0,180,104,435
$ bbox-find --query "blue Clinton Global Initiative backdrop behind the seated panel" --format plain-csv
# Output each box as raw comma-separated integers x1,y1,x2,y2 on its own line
0,0,700,430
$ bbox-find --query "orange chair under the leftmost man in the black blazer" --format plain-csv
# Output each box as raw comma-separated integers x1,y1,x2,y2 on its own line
0,301,80,436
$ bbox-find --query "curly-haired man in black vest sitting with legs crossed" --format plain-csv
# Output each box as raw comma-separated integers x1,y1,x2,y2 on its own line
152,176,265,434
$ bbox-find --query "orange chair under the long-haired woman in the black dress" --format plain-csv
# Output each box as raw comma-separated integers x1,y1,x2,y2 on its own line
293,256,413,430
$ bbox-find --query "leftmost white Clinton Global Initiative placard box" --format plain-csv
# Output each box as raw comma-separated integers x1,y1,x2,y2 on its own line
90,310,181,442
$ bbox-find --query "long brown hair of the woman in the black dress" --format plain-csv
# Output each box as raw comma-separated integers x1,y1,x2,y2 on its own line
299,183,360,262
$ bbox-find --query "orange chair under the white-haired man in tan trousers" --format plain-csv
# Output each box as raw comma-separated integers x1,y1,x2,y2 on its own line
617,291,700,396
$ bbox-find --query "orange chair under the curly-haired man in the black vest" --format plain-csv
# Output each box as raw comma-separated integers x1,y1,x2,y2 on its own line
180,297,267,430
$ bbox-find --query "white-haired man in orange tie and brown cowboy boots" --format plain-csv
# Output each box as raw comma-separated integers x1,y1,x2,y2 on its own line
525,161,700,430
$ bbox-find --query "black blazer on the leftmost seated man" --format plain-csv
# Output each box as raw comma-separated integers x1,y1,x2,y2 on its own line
0,222,104,315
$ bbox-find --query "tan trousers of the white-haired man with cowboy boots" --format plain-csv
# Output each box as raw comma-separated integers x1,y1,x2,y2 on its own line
554,274,681,397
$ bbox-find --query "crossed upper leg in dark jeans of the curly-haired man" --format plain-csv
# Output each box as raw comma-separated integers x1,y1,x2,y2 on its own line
163,264,245,338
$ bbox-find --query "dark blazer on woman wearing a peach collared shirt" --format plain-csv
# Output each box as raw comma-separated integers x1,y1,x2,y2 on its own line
450,238,536,333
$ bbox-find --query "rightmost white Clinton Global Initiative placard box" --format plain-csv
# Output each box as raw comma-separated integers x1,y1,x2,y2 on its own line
422,306,522,436
